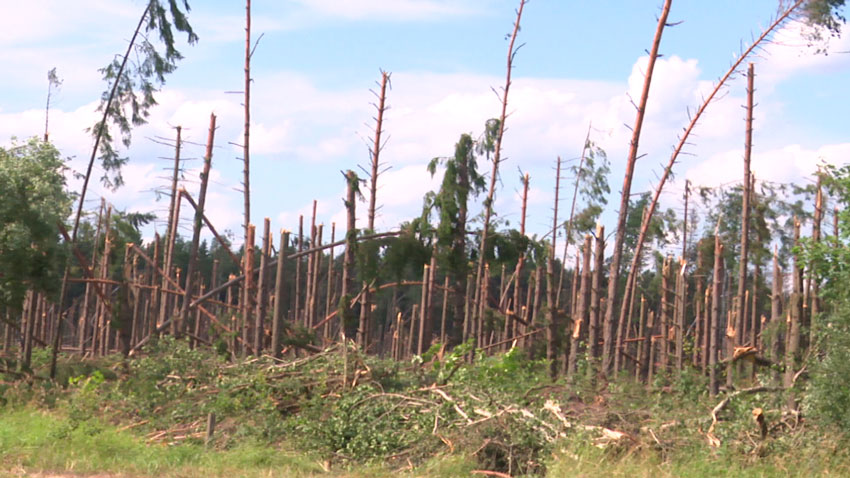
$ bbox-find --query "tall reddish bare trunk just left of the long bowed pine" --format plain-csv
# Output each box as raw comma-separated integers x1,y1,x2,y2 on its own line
602,0,672,374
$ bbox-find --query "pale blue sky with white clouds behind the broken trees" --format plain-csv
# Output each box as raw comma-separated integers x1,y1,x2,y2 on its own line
0,0,850,262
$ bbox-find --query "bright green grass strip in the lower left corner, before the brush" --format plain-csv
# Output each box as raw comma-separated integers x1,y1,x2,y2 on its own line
0,408,325,477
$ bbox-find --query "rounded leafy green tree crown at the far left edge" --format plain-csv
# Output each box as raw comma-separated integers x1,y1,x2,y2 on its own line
0,138,71,309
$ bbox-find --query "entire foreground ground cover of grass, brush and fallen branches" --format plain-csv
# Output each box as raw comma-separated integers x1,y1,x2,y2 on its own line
0,340,850,478
